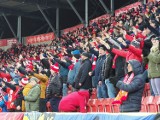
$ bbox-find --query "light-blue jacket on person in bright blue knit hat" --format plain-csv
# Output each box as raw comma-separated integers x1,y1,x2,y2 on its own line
67,60,81,85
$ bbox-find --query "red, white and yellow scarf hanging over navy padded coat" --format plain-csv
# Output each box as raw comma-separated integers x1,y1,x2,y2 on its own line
112,73,134,104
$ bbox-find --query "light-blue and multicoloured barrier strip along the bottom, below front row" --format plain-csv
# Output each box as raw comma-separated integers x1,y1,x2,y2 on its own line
0,112,158,120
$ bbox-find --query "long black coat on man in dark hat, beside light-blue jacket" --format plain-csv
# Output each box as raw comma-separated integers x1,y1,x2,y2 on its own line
75,59,92,89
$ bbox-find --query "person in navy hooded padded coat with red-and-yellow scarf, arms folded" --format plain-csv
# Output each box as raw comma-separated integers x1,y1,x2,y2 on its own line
113,60,147,112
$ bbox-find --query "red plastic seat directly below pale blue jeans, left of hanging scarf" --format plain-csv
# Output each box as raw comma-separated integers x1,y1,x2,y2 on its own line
103,98,114,113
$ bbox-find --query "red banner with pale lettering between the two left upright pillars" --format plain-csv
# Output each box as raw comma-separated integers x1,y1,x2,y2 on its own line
26,32,55,44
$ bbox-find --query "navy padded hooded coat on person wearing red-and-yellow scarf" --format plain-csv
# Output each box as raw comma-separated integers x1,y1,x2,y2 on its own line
116,60,147,112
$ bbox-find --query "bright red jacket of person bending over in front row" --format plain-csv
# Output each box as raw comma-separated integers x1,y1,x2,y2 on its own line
59,90,89,113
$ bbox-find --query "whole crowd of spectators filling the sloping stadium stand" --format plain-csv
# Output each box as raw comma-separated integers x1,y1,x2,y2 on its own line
0,2,160,112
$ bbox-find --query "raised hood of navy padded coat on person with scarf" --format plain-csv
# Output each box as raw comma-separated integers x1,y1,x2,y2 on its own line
128,60,143,76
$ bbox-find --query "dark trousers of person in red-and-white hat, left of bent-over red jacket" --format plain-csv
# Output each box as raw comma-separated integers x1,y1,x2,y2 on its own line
49,96,61,112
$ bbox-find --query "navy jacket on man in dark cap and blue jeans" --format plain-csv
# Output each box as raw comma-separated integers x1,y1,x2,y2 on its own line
92,55,106,84
